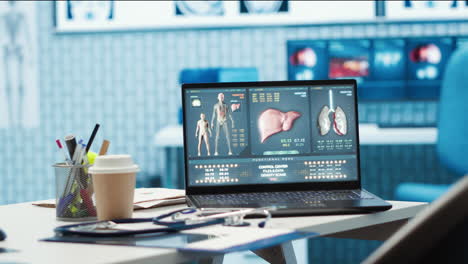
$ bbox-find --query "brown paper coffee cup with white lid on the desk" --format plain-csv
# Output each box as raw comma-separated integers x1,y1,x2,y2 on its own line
89,155,140,221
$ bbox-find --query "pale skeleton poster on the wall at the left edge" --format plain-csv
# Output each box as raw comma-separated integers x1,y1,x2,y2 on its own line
0,1,39,129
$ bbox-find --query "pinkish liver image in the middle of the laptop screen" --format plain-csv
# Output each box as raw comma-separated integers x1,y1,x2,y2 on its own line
258,108,301,143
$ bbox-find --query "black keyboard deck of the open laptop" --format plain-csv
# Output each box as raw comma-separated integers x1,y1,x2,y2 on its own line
192,190,374,206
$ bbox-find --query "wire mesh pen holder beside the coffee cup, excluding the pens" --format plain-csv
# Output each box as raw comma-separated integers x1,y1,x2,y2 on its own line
53,163,96,221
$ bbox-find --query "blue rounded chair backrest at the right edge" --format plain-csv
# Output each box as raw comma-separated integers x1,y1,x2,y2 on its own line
437,47,468,175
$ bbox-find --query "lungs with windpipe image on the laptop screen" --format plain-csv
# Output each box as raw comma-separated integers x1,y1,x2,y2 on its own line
317,90,348,136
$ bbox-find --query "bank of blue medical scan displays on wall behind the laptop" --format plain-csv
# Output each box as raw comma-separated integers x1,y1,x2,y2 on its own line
288,37,458,100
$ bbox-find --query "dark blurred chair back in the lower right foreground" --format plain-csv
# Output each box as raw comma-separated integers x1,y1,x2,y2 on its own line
364,176,468,264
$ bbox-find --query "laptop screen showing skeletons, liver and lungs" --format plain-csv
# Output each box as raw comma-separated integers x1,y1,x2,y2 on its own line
183,81,359,188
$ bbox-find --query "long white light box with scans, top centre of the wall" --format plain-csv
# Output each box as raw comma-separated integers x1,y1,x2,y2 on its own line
55,0,375,32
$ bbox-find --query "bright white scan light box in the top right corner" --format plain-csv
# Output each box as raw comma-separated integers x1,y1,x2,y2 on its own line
386,0,468,20
